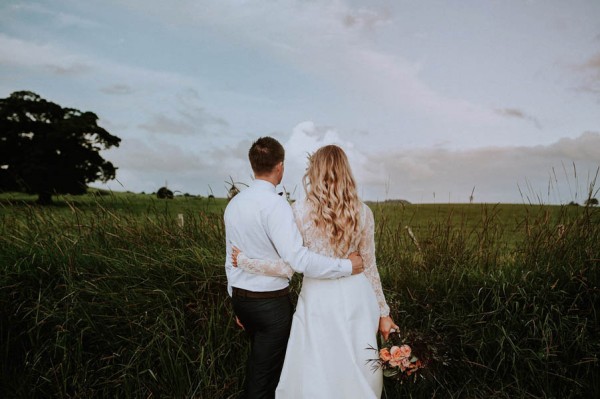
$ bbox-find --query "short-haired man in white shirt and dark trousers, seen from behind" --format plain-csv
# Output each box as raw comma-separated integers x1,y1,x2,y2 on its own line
224,137,363,399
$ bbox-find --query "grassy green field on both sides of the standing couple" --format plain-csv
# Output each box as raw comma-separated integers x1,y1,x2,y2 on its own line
0,194,600,398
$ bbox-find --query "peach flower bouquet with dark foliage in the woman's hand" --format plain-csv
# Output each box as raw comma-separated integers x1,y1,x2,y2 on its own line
368,331,447,382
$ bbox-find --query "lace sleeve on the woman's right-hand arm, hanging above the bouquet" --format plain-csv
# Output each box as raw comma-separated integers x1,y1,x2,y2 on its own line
360,205,390,317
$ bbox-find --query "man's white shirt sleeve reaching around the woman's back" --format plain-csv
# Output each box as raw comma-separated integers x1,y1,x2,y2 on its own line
265,198,352,279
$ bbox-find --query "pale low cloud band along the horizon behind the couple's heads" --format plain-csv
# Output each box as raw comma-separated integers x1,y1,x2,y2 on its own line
94,115,600,203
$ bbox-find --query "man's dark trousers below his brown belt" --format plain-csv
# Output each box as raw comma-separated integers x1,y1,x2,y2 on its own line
232,295,294,399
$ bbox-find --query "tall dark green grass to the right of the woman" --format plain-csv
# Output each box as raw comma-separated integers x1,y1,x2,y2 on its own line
377,205,600,398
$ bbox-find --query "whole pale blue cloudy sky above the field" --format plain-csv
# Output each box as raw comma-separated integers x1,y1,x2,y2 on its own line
0,0,600,204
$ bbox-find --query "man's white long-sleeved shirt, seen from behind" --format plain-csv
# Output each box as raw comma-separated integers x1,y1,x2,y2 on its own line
224,179,352,295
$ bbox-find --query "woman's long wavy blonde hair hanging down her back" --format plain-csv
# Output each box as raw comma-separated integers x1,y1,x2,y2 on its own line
302,145,361,257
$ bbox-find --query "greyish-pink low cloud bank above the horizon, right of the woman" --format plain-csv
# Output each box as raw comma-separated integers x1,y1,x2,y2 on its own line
362,132,600,203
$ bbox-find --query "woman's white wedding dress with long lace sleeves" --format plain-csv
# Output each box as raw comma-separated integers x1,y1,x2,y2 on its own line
238,201,389,399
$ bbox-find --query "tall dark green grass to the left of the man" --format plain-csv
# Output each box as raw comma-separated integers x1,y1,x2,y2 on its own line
0,196,246,398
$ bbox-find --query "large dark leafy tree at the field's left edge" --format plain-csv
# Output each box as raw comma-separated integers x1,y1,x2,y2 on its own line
0,91,121,204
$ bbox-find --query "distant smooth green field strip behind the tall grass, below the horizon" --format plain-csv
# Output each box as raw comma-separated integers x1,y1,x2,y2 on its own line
0,192,584,246
